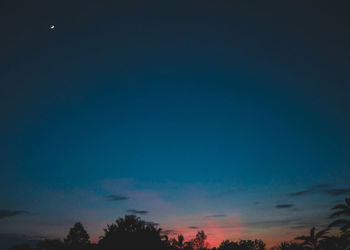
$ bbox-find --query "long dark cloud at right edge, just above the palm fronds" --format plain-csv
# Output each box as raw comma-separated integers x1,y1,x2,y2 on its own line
287,184,350,197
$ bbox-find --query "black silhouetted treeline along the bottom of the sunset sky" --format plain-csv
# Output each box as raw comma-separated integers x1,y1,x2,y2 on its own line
10,199,350,250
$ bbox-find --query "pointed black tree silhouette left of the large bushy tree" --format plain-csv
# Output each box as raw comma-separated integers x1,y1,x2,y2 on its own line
64,222,90,249
